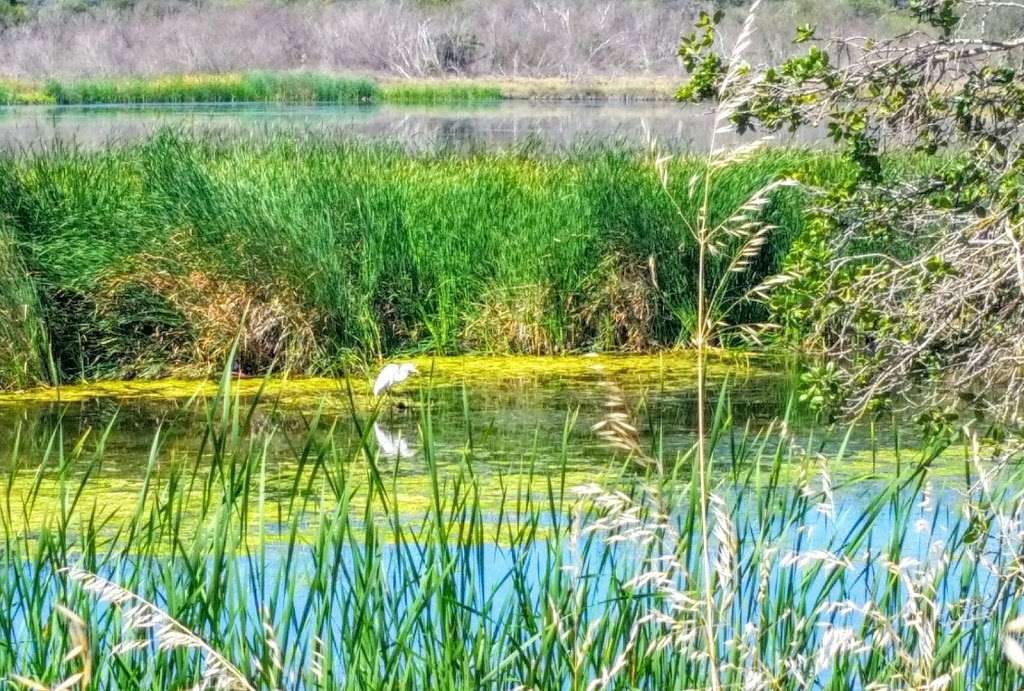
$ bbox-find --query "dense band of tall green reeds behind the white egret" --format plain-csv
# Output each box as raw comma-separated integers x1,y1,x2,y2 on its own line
0,132,845,386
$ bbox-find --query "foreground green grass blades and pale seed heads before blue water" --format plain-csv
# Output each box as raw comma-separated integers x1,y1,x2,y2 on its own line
0,368,1021,691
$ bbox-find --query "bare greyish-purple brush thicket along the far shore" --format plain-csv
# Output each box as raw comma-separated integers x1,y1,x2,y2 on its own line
0,0,909,79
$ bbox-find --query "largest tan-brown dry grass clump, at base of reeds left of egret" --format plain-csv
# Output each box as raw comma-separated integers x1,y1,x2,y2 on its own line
96,249,323,374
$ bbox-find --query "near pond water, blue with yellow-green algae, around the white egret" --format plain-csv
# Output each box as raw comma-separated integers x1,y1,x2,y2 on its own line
0,352,1005,689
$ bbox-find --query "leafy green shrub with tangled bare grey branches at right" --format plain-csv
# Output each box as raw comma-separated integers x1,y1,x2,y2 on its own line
679,0,1024,425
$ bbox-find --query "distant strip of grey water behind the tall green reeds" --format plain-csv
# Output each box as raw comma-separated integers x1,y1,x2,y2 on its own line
0,101,816,152
